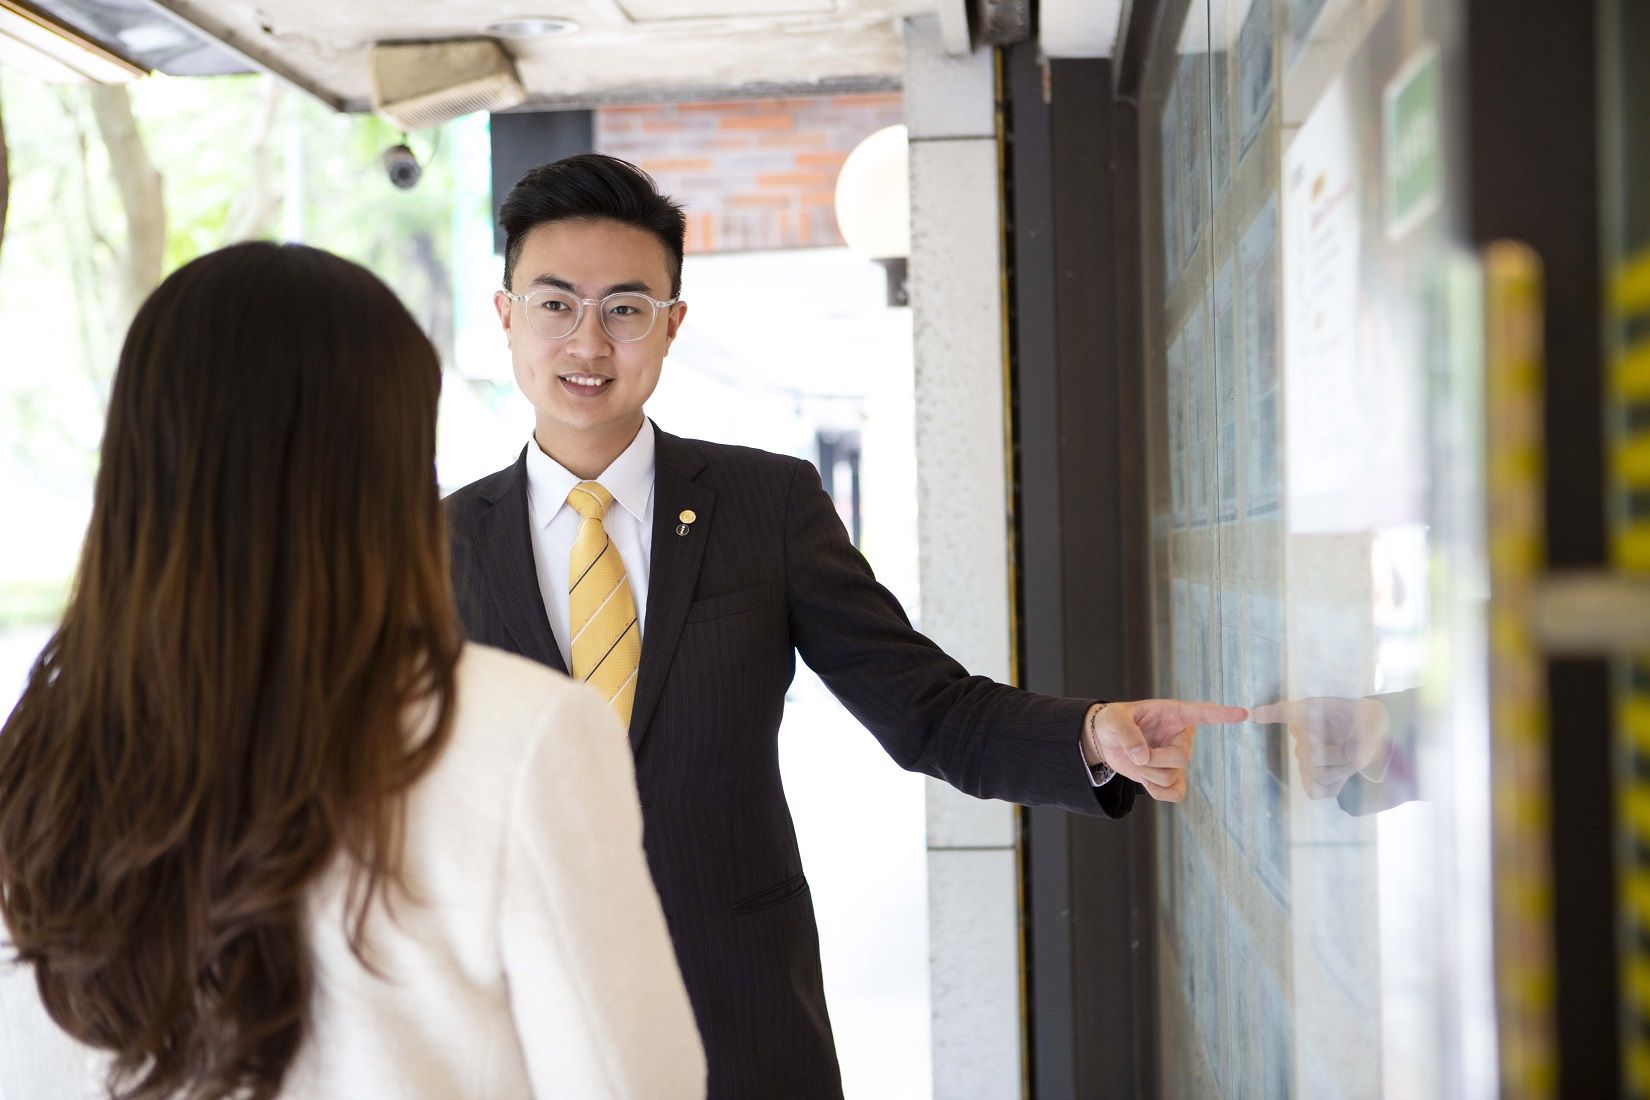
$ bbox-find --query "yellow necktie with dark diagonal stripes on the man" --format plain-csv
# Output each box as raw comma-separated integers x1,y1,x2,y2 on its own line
568,482,642,726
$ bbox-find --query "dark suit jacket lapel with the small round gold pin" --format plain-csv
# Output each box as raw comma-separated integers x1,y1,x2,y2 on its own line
630,425,716,750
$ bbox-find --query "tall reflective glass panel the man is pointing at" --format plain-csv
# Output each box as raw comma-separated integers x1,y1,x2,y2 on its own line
1142,0,1495,1100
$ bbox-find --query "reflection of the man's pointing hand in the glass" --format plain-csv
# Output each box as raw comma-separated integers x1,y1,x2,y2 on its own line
1251,696,1393,798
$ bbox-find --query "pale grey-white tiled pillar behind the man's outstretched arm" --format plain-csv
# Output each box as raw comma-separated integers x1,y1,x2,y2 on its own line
904,16,1023,1100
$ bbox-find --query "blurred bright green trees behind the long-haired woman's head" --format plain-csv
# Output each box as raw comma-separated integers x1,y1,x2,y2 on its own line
0,71,468,628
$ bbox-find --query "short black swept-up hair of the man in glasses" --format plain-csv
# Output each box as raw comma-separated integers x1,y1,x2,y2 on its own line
498,153,688,297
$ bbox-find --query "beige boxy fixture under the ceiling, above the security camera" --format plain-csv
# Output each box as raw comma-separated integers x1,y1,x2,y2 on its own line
370,38,526,130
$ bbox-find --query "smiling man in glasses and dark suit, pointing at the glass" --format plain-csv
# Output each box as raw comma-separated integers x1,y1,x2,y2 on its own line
447,155,1244,1100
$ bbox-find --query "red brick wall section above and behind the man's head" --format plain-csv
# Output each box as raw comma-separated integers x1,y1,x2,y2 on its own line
596,92,904,252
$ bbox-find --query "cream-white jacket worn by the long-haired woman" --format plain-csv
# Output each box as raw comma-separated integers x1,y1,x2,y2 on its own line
0,645,705,1100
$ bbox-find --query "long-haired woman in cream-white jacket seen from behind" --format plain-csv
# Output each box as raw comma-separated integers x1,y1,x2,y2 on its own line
0,244,705,1100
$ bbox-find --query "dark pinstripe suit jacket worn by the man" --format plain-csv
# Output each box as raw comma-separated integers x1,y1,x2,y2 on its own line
447,432,1137,1100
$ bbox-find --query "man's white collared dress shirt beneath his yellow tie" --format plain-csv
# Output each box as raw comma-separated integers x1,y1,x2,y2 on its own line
526,417,653,670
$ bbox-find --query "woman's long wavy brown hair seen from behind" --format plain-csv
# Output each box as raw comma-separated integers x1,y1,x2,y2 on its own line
0,244,460,1100
